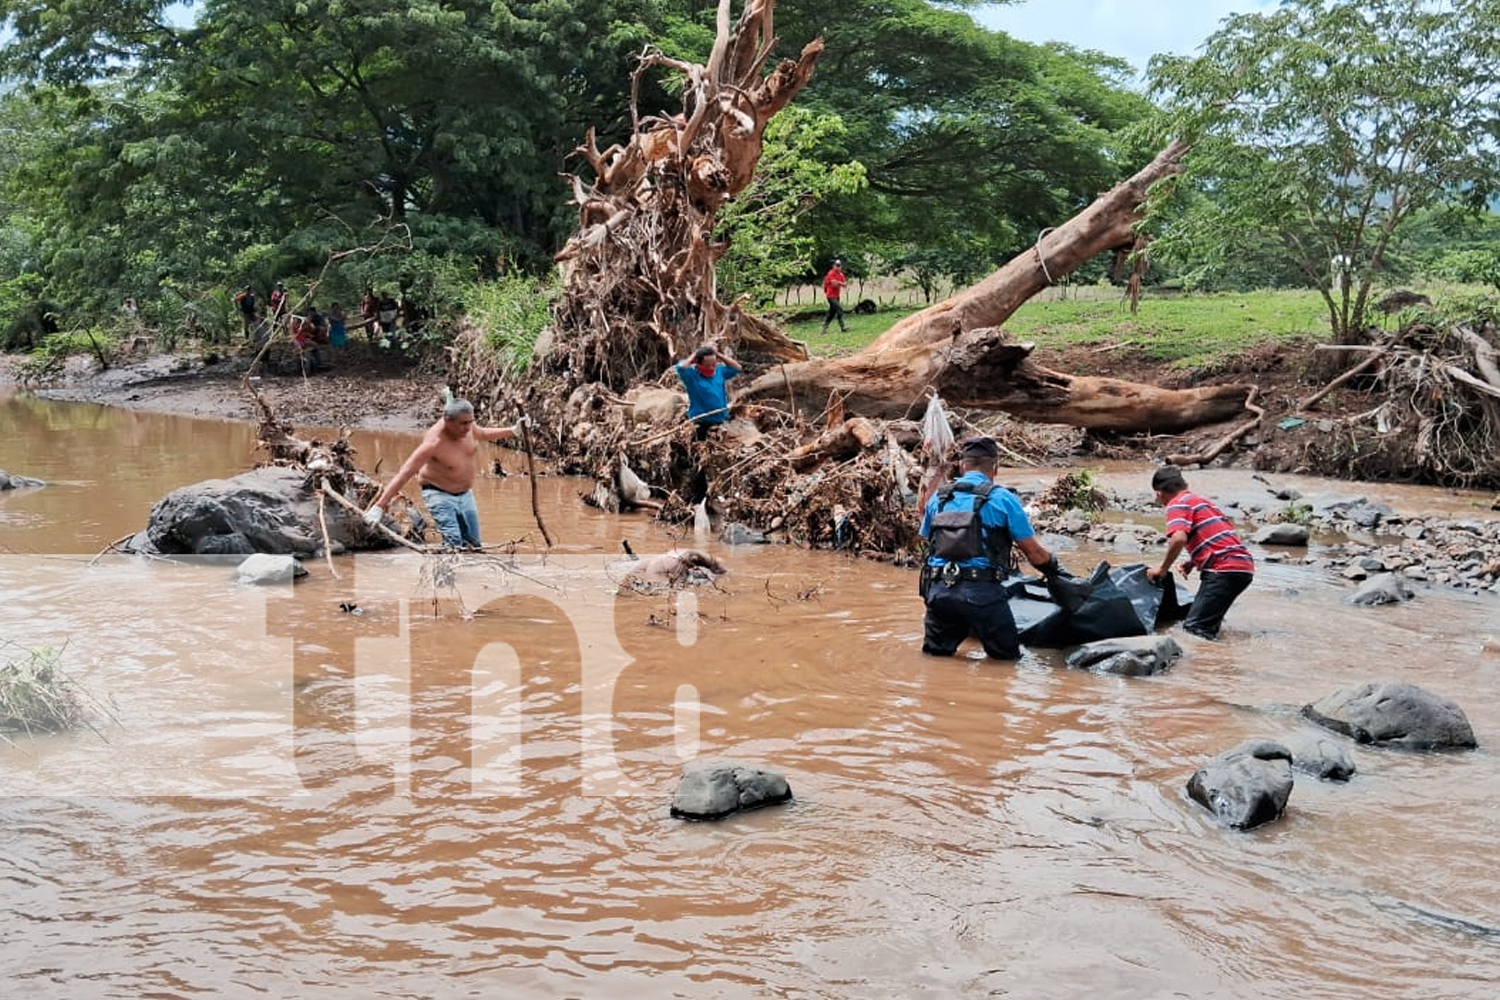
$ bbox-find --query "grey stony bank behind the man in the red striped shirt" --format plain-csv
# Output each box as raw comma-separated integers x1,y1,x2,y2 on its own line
1037,490,1500,603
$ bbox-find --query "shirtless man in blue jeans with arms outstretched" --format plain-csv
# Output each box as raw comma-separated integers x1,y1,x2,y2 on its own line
365,399,531,549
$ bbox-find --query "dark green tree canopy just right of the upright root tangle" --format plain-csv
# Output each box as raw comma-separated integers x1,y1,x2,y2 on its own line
777,0,1151,289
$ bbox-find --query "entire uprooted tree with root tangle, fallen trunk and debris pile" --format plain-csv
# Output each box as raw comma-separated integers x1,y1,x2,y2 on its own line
473,0,1278,553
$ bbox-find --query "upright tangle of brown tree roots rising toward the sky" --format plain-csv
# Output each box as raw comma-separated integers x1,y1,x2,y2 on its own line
539,0,824,393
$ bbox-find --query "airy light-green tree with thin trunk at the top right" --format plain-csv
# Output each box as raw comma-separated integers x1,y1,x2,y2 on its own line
1149,0,1500,343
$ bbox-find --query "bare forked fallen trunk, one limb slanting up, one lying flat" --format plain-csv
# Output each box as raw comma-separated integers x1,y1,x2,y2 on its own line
740,142,1251,432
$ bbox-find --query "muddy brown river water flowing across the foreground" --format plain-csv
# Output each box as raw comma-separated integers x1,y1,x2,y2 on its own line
0,396,1500,1000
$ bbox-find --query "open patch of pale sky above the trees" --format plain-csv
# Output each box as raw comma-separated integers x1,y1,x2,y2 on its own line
974,0,1275,72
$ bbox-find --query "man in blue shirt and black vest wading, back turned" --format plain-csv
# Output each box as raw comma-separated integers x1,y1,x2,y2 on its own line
921,438,1064,660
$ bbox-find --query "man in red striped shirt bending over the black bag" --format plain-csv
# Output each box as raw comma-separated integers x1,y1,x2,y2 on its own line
1146,465,1256,639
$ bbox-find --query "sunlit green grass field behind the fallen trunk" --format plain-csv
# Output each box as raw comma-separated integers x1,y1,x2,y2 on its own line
786,288,1328,370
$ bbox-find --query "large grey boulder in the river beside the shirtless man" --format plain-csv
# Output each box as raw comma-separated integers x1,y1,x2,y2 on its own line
131,466,381,556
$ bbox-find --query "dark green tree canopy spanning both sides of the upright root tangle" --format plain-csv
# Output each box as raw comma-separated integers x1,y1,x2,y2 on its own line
0,0,1145,340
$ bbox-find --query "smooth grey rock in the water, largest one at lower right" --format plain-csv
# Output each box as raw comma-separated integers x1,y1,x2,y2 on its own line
1302,681,1478,750
